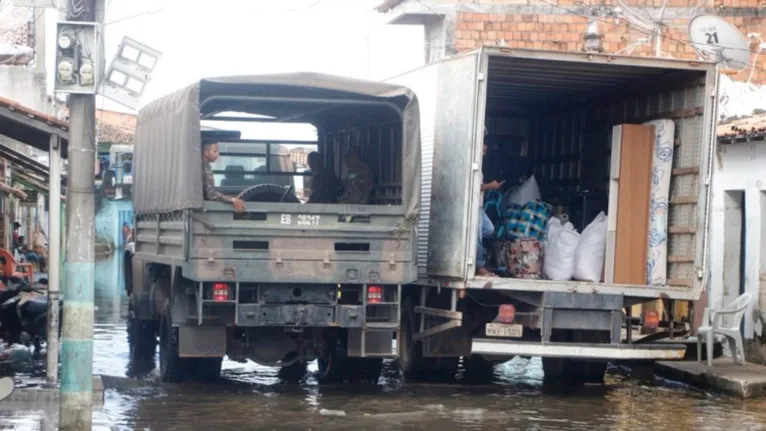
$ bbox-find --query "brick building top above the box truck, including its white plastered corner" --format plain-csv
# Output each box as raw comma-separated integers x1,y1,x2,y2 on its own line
378,0,766,83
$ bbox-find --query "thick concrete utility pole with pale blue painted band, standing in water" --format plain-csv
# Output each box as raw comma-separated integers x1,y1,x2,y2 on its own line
59,0,98,431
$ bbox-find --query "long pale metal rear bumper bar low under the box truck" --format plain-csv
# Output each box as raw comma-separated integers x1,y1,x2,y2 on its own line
471,338,686,361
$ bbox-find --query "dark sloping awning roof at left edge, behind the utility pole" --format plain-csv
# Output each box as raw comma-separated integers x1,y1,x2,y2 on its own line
0,97,69,158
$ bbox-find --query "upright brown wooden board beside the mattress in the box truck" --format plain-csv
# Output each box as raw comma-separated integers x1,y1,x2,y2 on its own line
605,124,654,284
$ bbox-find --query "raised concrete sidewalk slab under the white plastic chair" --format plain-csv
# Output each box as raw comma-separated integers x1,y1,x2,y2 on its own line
655,357,766,399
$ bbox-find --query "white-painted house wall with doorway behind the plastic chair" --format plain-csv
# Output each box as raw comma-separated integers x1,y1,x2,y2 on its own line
709,142,766,364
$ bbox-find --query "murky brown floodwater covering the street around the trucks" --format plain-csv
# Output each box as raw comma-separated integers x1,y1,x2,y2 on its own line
0,255,766,431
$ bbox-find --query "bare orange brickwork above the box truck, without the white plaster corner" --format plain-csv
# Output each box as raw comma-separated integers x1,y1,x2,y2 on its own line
442,0,766,83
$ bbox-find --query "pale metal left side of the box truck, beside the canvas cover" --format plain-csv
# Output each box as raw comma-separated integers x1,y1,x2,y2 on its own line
388,52,484,279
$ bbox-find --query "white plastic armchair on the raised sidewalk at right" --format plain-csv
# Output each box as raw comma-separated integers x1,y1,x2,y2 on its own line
697,293,752,367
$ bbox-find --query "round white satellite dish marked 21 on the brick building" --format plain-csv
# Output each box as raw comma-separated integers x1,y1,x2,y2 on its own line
689,15,752,70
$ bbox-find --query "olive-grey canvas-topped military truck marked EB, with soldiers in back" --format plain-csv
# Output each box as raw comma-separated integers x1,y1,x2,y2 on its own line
124,73,421,382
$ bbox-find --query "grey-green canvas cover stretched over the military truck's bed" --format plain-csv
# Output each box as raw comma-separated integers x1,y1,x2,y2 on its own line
133,73,421,220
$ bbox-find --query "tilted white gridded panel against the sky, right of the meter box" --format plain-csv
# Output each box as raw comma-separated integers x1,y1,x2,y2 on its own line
99,37,162,109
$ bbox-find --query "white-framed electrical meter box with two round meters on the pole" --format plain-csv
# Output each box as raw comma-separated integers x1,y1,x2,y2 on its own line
53,21,101,94
